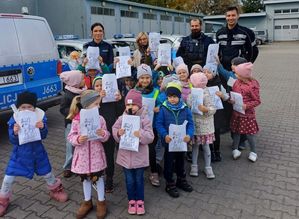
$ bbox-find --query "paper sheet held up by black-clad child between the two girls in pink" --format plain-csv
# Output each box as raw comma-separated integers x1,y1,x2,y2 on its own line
102,74,118,103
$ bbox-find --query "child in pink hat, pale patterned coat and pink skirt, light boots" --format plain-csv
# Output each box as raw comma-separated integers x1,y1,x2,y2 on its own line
188,73,216,179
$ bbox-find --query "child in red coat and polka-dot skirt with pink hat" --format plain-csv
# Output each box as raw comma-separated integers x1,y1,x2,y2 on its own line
231,62,261,162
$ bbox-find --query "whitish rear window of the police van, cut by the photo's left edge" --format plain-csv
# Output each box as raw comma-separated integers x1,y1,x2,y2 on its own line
0,18,21,66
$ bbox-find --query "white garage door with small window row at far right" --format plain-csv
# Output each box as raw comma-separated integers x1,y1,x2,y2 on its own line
274,19,299,41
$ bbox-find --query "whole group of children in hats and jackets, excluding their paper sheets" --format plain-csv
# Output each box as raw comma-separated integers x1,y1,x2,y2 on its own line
0,53,260,218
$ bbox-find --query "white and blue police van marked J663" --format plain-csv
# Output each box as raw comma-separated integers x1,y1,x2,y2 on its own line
0,13,62,120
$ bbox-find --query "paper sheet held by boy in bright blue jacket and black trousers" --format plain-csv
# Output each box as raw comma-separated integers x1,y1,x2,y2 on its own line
169,120,187,152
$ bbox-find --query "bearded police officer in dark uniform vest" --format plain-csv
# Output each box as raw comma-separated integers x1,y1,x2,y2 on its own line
176,19,215,70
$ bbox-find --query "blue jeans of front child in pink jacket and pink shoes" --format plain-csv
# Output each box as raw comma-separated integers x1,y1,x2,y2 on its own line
123,167,144,201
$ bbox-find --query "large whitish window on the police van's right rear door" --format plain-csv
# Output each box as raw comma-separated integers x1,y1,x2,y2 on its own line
15,19,57,62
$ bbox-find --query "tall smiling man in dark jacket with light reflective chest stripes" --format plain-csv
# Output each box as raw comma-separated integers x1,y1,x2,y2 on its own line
216,6,258,70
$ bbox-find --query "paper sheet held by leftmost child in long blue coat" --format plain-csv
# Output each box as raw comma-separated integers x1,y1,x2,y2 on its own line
16,110,41,145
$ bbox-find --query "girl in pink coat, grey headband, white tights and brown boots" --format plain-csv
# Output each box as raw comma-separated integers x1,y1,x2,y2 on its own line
67,90,110,218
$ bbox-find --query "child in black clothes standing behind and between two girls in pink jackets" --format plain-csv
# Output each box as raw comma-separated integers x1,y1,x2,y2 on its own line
93,76,124,193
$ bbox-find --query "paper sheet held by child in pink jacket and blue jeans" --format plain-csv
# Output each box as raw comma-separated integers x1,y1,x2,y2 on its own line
119,115,140,152
